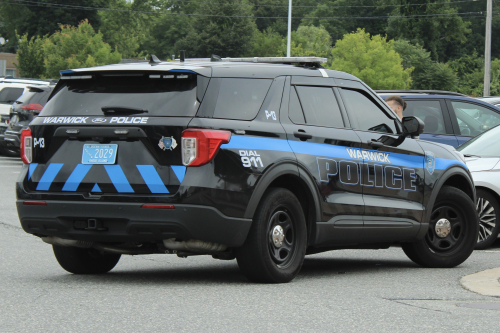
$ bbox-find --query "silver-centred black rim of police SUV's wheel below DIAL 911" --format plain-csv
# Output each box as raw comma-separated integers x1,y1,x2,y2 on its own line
268,208,296,268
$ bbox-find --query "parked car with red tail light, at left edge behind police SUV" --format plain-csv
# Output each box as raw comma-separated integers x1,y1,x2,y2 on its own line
0,85,55,156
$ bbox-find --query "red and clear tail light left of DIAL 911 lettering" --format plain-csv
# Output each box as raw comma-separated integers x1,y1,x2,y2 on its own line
182,129,231,166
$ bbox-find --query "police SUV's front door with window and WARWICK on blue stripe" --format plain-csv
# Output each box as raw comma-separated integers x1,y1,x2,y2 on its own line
339,80,424,242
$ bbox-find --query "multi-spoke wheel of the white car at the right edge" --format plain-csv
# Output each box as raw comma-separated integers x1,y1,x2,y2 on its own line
476,190,500,250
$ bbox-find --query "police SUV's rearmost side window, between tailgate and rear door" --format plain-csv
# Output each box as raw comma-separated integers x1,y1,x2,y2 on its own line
214,79,272,120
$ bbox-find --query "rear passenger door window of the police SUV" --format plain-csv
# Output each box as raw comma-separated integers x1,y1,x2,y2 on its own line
289,86,344,127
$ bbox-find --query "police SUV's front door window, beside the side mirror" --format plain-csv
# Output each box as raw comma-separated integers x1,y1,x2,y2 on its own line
341,88,397,133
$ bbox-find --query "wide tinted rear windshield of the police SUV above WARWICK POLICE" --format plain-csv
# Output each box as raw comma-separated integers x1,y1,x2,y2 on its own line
40,73,199,117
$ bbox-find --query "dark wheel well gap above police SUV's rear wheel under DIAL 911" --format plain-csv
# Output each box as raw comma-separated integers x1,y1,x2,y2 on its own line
269,175,316,243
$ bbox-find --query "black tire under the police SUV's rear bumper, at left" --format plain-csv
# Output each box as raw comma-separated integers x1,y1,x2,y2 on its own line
52,245,121,274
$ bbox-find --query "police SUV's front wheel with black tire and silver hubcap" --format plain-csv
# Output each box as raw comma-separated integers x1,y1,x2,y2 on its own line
401,186,479,268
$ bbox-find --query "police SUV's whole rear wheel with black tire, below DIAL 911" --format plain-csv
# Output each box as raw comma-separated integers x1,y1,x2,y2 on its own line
236,188,307,283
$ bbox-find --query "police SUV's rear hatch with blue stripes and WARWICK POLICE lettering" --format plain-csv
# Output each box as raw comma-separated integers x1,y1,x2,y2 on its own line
26,71,208,195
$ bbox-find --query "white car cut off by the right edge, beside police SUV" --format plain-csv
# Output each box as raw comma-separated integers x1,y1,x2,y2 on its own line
458,126,500,249
